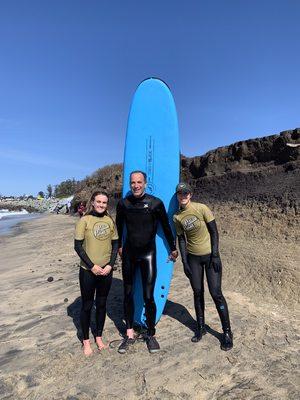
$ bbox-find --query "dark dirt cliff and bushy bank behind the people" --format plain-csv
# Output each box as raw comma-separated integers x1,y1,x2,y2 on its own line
75,129,300,212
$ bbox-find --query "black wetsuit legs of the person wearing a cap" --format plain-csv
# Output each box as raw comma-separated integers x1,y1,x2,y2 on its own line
187,254,230,332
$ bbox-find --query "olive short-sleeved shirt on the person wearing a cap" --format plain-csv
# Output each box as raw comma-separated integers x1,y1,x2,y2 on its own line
173,202,215,256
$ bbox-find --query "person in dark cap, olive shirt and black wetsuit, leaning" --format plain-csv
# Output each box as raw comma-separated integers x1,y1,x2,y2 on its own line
173,182,233,351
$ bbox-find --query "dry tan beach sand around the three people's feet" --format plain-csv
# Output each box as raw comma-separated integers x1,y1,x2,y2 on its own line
0,209,300,400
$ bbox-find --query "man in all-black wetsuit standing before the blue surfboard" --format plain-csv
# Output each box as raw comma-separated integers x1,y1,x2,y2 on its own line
116,171,178,353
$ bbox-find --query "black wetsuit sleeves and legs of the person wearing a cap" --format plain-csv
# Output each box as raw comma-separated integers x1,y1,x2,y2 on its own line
178,220,231,332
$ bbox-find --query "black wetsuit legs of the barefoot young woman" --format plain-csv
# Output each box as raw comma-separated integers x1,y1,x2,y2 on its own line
79,268,112,340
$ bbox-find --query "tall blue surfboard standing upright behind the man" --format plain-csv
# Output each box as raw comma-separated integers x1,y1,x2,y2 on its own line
123,78,180,326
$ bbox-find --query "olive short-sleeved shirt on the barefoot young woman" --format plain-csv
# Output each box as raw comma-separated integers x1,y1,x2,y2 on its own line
75,215,118,269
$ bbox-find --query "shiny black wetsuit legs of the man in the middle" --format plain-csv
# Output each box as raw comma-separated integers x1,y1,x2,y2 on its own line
122,246,157,336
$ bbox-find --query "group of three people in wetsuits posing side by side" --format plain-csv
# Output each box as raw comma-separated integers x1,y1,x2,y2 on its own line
75,171,233,356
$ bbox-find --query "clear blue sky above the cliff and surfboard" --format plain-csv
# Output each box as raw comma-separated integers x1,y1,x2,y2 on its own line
0,0,300,195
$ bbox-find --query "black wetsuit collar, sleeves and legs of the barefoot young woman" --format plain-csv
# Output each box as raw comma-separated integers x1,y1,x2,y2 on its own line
74,211,118,340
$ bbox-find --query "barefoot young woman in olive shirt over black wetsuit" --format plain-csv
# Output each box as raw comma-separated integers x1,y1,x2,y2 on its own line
74,191,118,356
